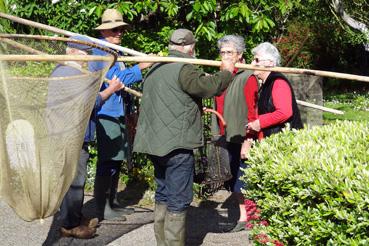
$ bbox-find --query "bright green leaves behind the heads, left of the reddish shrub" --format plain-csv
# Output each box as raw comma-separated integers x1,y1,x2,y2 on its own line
5,0,308,63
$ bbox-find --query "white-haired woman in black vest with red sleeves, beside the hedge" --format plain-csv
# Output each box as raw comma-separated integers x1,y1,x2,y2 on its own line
244,42,303,137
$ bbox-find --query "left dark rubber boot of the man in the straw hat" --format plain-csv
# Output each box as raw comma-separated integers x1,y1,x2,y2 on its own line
94,176,127,221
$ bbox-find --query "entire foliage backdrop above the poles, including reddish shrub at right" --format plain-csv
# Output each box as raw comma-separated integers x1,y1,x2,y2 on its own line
2,0,369,74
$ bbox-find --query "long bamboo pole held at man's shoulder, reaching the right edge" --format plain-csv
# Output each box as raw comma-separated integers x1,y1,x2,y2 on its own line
118,56,369,82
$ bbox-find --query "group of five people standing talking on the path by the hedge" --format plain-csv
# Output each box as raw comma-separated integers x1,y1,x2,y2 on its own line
54,9,302,246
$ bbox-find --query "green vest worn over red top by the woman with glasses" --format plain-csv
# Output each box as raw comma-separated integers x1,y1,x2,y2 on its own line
223,70,252,143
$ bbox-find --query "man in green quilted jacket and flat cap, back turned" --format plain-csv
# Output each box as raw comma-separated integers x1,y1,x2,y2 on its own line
133,29,234,246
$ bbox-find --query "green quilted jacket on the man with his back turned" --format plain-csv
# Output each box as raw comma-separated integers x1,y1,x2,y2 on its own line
133,51,232,156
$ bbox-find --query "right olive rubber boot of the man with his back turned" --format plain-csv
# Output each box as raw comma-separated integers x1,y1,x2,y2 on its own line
164,211,186,246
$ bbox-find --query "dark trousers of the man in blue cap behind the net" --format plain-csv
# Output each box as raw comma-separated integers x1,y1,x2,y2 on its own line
60,144,89,229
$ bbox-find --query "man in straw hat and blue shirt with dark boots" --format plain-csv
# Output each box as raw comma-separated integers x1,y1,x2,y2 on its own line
92,9,152,220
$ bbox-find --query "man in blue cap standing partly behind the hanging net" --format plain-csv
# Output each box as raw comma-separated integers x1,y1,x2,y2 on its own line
49,36,123,239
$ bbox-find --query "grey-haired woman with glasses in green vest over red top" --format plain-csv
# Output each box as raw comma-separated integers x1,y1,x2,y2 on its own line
215,35,258,232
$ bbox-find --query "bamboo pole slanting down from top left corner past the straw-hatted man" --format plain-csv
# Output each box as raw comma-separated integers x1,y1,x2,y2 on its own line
0,12,146,56
